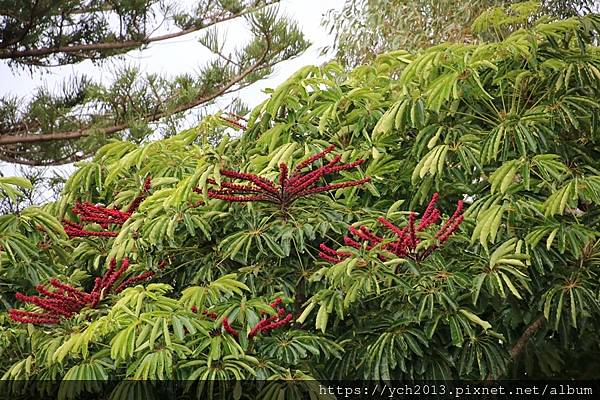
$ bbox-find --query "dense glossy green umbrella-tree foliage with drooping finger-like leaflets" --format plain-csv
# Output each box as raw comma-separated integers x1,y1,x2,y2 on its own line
0,2,600,398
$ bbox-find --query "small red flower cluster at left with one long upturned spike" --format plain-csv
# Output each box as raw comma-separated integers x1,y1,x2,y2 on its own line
63,177,151,237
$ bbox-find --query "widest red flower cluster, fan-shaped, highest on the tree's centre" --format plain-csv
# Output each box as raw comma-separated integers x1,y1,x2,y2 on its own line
194,145,371,209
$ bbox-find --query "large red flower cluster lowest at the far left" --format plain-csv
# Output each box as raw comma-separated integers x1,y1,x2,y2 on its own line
8,258,154,324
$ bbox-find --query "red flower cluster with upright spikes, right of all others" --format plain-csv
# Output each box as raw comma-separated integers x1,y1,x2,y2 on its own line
319,193,464,264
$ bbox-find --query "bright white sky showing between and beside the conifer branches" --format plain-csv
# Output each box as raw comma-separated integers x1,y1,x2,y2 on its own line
0,0,344,176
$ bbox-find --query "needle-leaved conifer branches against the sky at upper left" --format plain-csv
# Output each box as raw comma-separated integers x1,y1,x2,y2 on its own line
0,0,307,166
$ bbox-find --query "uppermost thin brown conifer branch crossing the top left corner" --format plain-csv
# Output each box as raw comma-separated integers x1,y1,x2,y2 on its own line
0,0,280,59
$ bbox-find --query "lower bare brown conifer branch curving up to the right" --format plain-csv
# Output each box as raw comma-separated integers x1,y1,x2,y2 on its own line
0,46,270,145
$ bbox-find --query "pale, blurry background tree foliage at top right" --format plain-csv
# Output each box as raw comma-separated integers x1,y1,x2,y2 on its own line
324,0,595,67
